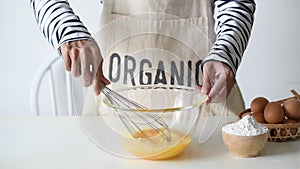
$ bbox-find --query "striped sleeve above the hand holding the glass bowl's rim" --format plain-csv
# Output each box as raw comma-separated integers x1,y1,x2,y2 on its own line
203,0,256,75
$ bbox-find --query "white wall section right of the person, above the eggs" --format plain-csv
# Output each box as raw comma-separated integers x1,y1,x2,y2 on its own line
237,0,300,105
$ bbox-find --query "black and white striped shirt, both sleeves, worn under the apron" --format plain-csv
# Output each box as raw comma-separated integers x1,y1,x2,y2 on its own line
30,0,255,74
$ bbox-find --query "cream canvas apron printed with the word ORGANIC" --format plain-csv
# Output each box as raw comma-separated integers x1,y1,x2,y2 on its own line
83,0,245,115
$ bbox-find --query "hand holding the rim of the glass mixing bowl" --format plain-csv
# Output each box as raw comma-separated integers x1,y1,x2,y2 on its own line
201,61,236,103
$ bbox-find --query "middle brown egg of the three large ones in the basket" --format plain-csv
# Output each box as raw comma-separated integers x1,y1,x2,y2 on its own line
264,102,285,124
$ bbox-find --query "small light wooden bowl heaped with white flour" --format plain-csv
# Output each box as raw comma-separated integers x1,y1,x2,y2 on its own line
222,115,269,157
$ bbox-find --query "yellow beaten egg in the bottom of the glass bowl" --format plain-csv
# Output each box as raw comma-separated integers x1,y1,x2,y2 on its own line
124,129,192,160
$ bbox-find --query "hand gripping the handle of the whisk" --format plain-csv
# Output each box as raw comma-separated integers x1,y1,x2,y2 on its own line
60,40,110,95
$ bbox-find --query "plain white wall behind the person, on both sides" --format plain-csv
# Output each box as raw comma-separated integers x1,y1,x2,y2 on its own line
0,0,300,115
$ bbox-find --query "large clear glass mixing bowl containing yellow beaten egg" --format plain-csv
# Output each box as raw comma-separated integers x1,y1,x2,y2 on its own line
98,85,208,160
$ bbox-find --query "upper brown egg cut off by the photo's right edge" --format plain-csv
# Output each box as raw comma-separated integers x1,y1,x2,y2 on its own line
283,99,300,119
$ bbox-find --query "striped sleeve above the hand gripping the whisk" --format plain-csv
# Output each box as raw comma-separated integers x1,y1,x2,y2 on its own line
30,0,92,50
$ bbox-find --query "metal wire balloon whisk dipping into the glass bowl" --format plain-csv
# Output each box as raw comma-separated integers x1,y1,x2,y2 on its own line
102,86,171,141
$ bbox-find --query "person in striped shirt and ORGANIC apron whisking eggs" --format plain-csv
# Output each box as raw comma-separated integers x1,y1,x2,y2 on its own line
31,0,255,114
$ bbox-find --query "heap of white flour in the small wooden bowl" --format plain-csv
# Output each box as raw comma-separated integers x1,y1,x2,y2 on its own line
222,115,268,136
